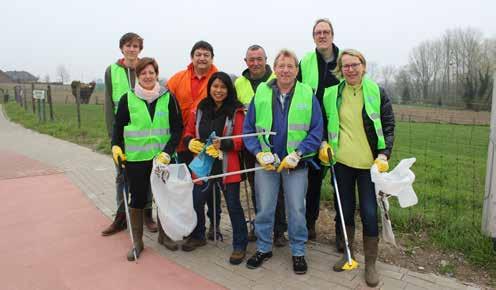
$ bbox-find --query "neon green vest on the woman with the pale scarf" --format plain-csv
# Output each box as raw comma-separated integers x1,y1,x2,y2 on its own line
124,91,170,161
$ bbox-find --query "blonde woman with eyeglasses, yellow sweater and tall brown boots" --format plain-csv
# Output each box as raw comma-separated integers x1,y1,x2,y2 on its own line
319,49,395,287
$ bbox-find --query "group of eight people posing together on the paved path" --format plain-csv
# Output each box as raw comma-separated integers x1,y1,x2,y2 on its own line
102,19,395,287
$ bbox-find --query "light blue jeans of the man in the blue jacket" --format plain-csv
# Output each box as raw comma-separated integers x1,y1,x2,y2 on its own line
255,168,308,256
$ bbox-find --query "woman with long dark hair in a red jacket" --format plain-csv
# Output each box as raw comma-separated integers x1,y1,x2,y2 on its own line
182,72,248,265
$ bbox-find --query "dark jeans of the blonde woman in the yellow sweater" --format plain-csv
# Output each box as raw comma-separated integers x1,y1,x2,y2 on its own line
334,163,379,237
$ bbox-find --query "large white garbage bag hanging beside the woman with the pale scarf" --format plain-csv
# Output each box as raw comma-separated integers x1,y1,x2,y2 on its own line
150,159,197,241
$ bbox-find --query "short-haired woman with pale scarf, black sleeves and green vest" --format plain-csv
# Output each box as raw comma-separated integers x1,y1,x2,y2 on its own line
112,57,183,261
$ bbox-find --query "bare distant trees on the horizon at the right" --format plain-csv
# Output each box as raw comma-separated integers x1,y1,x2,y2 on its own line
374,28,496,110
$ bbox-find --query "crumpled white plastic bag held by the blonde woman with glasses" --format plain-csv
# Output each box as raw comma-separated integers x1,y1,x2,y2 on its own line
370,158,418,246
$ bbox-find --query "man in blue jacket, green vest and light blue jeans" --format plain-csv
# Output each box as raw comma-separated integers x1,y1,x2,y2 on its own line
243,50,323,274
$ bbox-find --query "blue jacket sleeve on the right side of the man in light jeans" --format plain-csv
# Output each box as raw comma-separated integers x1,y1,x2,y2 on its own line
298,96,323,155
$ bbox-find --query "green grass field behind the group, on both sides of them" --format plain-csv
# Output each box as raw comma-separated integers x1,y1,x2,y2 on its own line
5,102,496,277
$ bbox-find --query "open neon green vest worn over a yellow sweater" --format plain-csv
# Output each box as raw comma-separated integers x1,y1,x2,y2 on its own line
324,78,386,159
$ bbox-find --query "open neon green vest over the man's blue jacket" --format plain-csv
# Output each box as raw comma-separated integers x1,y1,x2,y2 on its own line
254,82,315,157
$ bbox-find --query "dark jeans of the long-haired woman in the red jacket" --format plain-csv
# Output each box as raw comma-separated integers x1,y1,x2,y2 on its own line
191,182,248,251
